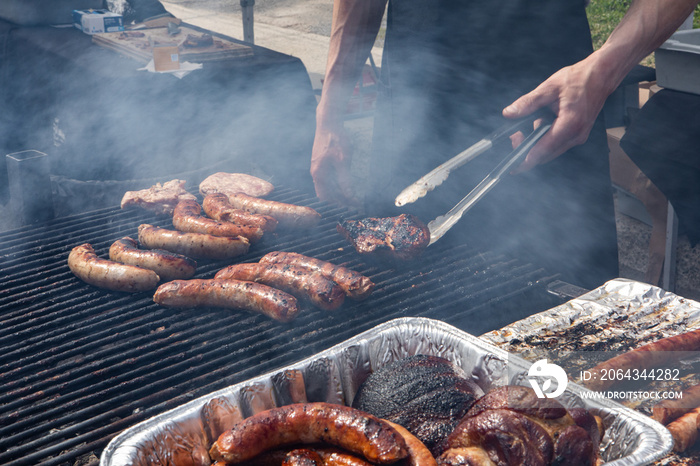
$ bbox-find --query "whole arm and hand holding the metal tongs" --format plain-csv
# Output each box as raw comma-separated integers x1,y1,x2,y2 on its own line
503,0,698,171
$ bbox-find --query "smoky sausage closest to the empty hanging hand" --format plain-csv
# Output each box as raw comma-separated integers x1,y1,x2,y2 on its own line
228,193,321,228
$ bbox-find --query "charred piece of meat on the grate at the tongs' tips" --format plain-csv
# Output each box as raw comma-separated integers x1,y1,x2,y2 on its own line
337,214,430,260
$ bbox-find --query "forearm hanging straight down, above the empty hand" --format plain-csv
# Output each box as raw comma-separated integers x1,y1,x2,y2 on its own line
316,0,387,125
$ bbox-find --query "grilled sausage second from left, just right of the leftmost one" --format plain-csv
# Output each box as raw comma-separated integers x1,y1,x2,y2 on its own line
109,236,197,281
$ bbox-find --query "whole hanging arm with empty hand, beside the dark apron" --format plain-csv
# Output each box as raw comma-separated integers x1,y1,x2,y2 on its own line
311,0,387,203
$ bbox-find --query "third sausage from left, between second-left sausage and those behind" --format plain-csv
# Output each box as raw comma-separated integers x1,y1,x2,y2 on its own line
139,223,250,259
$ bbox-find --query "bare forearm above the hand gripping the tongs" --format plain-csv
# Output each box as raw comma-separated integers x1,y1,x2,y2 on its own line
590,0,698,92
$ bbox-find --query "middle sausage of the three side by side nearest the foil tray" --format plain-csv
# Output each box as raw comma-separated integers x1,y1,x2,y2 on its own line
214,263,345,311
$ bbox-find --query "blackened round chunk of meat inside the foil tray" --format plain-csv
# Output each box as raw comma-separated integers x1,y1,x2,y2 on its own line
352,355,483,455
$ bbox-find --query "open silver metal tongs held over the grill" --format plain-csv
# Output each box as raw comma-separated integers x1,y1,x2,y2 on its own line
394,109,554,245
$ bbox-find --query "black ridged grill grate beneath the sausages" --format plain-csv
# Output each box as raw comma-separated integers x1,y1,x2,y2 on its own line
0,184,561,464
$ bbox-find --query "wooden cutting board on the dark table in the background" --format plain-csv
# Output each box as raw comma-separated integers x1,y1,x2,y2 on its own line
92,26,253,63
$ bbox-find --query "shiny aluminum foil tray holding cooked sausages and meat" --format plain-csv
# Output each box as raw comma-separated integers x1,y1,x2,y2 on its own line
101,318,672,466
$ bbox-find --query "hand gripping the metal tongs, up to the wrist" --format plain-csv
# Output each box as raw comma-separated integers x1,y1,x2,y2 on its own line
503,57,610,173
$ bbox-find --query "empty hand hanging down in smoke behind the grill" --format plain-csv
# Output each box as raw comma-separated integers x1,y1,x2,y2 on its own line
311,124,359,206
